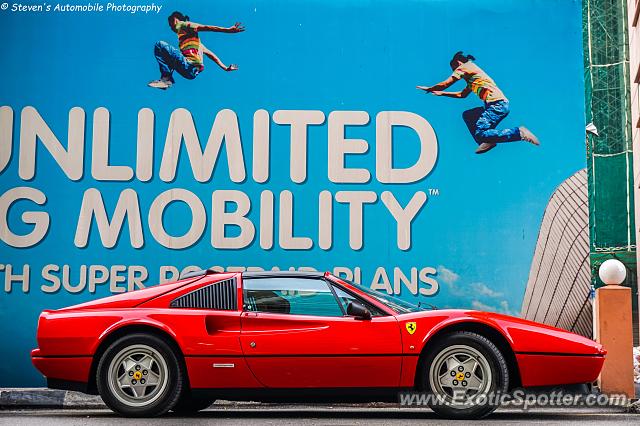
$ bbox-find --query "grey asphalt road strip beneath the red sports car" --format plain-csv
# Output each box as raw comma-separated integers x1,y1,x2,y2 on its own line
0,406,640,426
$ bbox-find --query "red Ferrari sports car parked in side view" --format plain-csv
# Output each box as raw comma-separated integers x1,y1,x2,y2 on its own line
31,271,605,418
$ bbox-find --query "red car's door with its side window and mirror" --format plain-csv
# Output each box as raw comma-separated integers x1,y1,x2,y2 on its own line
240,277,402,388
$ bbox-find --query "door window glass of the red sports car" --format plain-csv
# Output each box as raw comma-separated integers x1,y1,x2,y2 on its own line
243,277,344,317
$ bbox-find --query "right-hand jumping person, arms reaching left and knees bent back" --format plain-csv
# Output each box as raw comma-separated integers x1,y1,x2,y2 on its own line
417,52,540,154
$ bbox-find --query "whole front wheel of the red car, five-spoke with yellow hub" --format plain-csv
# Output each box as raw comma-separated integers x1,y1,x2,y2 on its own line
422,331,509,419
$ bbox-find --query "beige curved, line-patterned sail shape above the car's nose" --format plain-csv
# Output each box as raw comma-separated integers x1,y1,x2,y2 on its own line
521,169,593,337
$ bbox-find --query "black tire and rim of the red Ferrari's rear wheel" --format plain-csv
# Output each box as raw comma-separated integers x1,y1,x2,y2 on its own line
96,333,185,417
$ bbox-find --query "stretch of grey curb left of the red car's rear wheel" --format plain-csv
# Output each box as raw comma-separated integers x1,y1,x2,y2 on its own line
0,388,107,410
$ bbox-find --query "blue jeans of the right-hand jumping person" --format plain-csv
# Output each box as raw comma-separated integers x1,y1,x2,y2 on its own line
462,101,521,145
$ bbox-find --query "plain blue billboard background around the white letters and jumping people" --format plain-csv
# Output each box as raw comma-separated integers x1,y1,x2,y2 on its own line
0,0,585,386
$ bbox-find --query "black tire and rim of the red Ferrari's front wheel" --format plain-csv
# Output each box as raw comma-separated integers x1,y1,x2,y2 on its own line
419,331,509,419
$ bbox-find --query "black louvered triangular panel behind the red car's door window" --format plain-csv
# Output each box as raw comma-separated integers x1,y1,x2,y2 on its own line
169,278,238,311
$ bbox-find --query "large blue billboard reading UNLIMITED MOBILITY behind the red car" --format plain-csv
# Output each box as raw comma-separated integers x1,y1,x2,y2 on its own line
0,0,585,386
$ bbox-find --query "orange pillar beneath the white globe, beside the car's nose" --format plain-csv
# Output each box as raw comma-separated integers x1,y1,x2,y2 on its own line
594,285,635,398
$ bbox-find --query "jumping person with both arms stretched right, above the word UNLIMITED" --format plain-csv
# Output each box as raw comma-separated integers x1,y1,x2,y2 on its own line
149,12,244,90
